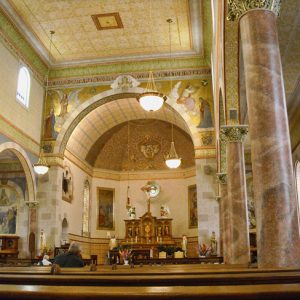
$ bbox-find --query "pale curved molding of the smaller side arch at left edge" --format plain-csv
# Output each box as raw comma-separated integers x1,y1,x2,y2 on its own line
0,142,36,202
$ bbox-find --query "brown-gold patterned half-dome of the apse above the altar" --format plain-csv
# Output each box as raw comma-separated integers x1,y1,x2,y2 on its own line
86,119,195,171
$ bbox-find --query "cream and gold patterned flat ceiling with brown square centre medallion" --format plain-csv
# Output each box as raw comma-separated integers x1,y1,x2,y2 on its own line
0,0,203,65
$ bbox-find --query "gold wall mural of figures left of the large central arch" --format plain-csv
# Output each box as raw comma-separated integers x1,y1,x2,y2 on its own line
45,88,82,133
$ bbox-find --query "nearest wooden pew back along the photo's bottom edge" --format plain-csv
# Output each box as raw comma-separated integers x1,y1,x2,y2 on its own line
0,284,300,300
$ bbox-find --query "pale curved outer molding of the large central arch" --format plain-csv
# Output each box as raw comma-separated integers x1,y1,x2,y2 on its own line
54,87,196,155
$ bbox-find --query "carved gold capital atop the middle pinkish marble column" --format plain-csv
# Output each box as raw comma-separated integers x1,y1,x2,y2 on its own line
220,125,248,143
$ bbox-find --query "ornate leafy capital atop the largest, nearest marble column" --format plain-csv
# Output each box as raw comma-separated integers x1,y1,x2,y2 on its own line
227,0,281,21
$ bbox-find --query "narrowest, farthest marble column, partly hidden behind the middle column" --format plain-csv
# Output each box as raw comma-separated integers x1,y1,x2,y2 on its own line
217,173,230,263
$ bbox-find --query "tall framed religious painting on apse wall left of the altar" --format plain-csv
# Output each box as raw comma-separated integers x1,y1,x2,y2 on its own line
97,187,115,230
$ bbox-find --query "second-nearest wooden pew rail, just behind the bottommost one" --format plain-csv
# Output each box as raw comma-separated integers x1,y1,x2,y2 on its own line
0,265,300,287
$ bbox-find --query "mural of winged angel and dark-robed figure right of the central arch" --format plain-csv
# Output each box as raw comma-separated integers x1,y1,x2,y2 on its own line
168,81,213,128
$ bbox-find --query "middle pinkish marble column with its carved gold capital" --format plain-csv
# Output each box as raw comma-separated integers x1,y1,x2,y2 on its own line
221,125,250,264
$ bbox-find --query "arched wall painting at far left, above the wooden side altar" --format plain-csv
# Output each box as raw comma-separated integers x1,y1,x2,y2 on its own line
0,185,18,234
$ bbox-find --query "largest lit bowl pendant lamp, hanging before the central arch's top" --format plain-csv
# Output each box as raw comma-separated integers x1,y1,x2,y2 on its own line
137,0,167,111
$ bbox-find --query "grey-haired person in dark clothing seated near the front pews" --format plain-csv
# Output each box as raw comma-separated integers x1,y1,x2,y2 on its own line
54,242,84,268
